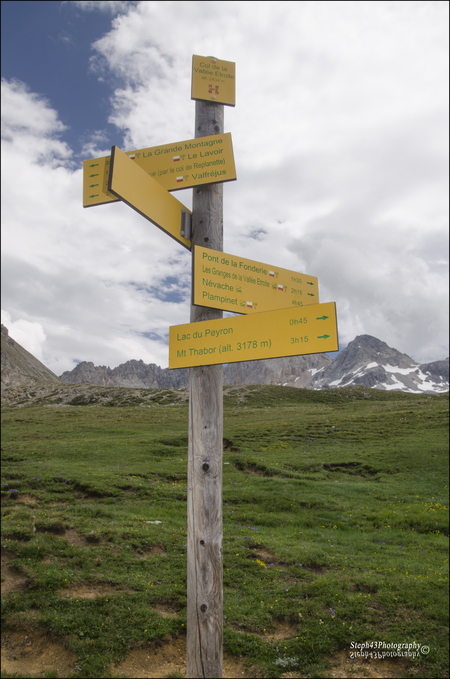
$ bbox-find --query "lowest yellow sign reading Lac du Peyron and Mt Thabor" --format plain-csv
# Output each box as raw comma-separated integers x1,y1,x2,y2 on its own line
169,302,339,368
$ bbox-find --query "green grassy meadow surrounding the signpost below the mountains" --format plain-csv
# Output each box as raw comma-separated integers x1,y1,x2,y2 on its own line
1,386,448,677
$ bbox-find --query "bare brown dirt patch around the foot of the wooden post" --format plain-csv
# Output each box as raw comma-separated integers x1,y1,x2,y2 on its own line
111,637,248,679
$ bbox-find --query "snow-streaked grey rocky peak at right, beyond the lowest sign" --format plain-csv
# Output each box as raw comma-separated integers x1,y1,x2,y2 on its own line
307,335,449,392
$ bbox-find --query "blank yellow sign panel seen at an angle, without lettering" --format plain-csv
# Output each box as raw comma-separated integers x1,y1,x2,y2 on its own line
108,146,191,250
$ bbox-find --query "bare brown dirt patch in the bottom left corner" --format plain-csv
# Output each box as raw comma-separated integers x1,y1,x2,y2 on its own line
2,624,78,677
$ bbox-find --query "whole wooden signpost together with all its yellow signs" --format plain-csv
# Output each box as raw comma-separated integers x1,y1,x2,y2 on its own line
83,55,338,678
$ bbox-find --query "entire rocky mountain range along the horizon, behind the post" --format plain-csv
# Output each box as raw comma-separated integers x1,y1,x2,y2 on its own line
1,325,449,393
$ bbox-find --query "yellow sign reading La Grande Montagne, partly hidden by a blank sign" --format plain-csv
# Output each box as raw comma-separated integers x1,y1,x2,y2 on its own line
83,132,236,207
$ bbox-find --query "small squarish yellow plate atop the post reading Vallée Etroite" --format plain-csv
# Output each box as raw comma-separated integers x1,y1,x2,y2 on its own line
191,54,236,106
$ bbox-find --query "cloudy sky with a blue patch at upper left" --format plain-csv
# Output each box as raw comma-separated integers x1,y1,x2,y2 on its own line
1,0,449,375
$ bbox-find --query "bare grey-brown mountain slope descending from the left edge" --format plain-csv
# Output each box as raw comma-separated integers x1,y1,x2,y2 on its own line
1,325,61,389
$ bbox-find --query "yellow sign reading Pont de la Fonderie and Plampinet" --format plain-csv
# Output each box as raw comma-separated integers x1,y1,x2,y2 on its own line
193,245,319,314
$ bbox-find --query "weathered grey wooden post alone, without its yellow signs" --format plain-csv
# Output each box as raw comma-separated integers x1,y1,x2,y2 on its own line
187,101,224,678
